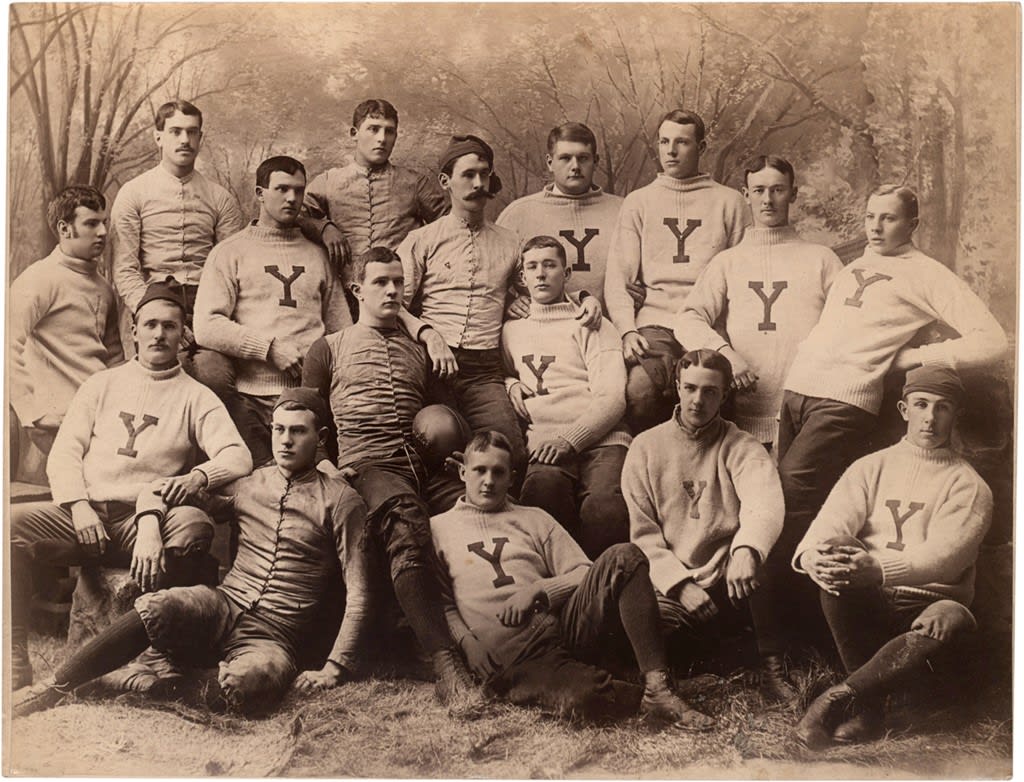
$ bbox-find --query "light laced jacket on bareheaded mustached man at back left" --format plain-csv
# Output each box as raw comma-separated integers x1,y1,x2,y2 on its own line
111,165,246,311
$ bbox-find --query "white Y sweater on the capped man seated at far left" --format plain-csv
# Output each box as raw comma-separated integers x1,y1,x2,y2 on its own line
46,358,253,505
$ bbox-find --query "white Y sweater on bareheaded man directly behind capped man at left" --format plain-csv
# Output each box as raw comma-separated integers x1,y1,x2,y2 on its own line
195,222,352,396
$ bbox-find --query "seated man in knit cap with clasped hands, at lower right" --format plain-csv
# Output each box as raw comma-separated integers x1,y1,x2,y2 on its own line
793,365,992,749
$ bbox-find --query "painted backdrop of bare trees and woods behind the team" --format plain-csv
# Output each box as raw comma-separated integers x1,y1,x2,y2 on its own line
8,4,1019,332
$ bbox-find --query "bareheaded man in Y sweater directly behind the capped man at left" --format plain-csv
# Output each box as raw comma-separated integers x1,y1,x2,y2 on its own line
196,156,351,466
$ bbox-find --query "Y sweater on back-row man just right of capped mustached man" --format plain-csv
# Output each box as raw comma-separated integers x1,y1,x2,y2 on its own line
496,182,623,306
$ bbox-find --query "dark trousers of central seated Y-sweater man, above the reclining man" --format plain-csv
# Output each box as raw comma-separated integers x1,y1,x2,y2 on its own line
519,445,630,559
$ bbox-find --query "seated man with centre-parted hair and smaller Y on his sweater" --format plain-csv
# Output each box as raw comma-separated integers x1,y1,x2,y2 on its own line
623,350,796,701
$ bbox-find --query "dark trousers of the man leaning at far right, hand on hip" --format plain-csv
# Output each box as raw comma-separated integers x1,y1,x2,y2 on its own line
751,391,877,654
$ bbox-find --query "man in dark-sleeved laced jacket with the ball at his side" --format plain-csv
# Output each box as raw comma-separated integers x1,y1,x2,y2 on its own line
302,247,470,702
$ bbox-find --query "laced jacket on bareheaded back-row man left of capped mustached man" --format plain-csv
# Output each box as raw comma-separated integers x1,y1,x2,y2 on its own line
303,160,447,257
